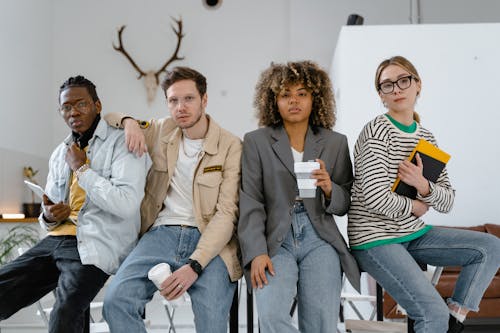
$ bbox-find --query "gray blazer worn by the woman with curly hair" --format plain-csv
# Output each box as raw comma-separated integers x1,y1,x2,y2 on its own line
238,126,360,291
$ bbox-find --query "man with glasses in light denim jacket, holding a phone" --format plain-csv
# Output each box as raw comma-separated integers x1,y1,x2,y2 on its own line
0,76,146,333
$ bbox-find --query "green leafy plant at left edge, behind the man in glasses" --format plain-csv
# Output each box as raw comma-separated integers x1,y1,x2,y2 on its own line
0,225,39,266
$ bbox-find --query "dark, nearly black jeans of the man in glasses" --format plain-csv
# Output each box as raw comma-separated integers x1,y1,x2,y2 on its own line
0,236,109,333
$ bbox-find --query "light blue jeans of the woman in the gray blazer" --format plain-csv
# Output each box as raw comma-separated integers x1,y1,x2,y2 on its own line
254,203,342,333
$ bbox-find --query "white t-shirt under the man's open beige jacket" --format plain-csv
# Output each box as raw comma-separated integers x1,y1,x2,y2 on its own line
153,136,203,227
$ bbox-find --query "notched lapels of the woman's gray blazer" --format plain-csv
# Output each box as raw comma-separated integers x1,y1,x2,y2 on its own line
271,126,323,177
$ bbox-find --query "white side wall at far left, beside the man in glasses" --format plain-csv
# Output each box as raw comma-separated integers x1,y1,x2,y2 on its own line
0,0,52,156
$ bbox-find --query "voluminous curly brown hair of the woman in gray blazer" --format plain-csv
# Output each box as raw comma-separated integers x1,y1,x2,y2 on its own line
254,61,336,131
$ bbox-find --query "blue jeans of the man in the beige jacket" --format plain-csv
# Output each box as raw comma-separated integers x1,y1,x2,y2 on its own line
103,225,236,333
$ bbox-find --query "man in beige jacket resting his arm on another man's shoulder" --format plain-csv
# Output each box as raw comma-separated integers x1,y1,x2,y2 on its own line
103,67,242,333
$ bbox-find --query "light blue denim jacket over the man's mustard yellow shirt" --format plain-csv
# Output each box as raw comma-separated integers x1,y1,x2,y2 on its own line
39,121,146,274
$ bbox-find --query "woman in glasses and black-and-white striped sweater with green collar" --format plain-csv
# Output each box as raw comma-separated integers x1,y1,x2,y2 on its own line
348,56,500,333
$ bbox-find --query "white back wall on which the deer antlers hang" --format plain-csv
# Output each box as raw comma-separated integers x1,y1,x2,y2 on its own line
48,0,500,144
